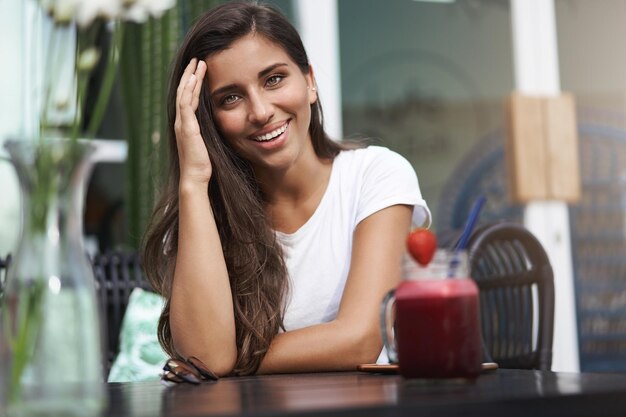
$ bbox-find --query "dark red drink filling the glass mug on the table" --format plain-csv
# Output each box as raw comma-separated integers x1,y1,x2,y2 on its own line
395,278,482,378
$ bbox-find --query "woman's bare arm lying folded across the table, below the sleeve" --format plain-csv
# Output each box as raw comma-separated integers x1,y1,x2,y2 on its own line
254,205,412,373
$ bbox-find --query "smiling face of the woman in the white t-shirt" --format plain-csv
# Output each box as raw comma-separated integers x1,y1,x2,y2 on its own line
205,34,317,170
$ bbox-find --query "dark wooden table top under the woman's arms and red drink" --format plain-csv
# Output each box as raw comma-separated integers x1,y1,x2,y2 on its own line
104,369,626,417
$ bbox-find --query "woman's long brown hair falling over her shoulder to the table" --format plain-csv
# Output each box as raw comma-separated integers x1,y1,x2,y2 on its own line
143,3,344,375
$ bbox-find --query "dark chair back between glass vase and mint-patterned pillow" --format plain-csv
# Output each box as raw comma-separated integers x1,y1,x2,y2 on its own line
92,252,151,372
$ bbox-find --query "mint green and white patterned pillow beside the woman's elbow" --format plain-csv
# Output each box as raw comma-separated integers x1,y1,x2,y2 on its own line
109,288,167,382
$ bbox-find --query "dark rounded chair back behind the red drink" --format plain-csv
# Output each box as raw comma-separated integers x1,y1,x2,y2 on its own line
468,222,554,370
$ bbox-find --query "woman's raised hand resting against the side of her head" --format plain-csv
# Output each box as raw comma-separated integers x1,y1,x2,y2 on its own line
174,58,212,186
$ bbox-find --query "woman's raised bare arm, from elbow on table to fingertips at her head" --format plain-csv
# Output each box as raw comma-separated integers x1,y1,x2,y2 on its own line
170,59,237,375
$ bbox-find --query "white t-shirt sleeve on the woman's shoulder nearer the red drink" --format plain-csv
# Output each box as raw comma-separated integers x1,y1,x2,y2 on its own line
356,146,431,227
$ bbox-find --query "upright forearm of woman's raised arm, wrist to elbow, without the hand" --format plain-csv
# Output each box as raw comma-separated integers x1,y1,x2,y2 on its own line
170,184,237,375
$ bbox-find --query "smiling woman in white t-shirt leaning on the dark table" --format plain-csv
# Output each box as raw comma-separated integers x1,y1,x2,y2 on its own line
143,3,430,375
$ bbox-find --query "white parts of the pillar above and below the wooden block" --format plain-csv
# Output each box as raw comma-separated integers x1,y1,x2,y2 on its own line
511,0,580,372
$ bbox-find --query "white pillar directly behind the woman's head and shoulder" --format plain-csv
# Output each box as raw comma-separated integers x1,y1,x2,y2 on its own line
293,0,343,139
